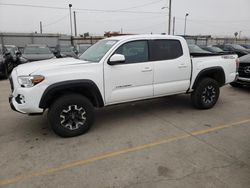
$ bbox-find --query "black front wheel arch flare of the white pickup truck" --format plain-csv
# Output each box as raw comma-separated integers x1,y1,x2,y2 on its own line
39,80,104,109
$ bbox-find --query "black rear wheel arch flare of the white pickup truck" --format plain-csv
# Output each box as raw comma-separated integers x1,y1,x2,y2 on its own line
192,67,226,89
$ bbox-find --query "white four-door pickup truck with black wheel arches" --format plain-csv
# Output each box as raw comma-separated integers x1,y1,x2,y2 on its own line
9,35,238,137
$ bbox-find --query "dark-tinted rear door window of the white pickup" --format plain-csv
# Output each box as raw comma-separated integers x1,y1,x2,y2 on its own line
150,39,183,61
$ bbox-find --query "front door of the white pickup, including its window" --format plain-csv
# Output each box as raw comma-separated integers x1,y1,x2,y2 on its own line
104,40,153,104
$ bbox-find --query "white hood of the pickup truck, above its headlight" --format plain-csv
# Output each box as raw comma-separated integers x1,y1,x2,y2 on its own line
16,58,90,75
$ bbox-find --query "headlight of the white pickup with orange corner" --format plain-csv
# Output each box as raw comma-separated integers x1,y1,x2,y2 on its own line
18,75,44,87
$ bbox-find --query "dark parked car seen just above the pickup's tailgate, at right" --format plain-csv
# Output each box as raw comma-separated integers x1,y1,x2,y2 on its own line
215,44,250,57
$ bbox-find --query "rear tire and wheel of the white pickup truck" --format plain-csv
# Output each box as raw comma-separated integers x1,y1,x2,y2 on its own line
191,78,220,109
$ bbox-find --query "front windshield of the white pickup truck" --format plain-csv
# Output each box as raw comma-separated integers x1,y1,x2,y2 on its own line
80,40,117,62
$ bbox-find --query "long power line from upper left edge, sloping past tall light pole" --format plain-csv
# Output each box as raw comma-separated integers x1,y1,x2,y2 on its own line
0,3,162,14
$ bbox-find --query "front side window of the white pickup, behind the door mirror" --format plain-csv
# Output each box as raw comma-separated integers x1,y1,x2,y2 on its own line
115,41,148,63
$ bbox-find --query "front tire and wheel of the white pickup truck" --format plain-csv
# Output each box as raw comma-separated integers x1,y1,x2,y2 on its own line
48,94,94,137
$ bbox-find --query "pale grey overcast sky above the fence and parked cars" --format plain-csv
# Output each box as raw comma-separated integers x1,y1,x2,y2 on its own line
0,0,250,38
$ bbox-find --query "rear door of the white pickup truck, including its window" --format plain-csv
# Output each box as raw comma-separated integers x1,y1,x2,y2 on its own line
150,39,191,96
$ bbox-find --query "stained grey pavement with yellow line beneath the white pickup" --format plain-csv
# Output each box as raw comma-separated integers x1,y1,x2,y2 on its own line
0,80,250,188
